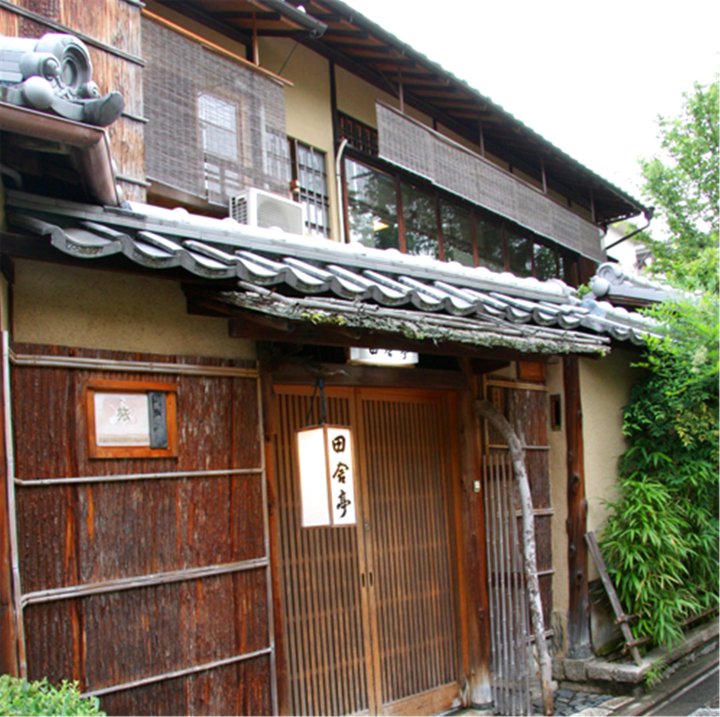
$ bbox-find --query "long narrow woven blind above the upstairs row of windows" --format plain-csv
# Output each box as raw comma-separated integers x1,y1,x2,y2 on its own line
375,103,605,261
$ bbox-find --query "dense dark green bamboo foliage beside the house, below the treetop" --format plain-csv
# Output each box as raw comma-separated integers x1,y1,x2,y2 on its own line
601,296,719,645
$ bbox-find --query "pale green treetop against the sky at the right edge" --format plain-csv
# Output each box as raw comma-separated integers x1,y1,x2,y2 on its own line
641,78,720,293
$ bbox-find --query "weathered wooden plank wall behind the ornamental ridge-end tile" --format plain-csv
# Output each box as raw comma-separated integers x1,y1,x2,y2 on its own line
0,0,146,201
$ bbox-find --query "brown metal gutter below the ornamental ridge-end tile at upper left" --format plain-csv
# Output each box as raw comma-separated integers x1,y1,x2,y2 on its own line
0,102,122,207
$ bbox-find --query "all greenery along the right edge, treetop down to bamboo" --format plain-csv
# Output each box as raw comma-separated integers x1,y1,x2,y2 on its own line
601,84,720,645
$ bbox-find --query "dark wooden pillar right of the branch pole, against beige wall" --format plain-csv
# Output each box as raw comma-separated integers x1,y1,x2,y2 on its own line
563,356,591,658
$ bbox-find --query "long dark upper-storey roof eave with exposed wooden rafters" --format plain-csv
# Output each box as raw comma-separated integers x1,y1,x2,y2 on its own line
155,0,646,226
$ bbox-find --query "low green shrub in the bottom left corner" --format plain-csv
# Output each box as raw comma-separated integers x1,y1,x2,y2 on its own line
0,675,105,716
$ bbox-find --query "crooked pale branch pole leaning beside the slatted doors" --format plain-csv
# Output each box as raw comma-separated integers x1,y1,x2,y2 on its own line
475,400,554,715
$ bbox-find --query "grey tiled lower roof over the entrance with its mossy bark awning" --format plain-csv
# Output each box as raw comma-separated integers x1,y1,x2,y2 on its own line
2,193,654,353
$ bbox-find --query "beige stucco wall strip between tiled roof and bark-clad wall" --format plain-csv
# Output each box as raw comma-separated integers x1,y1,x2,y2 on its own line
12,260,255,359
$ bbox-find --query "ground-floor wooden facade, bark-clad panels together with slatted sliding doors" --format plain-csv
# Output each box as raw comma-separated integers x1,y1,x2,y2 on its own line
0,334,564,714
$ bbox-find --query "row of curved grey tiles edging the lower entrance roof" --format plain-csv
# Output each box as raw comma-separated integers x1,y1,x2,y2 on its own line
8,206,659,345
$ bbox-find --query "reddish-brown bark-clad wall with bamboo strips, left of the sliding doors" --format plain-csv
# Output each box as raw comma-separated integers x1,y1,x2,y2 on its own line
4,346,274,715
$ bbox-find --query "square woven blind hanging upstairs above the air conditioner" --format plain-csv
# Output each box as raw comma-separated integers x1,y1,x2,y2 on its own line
142,18,289,204
